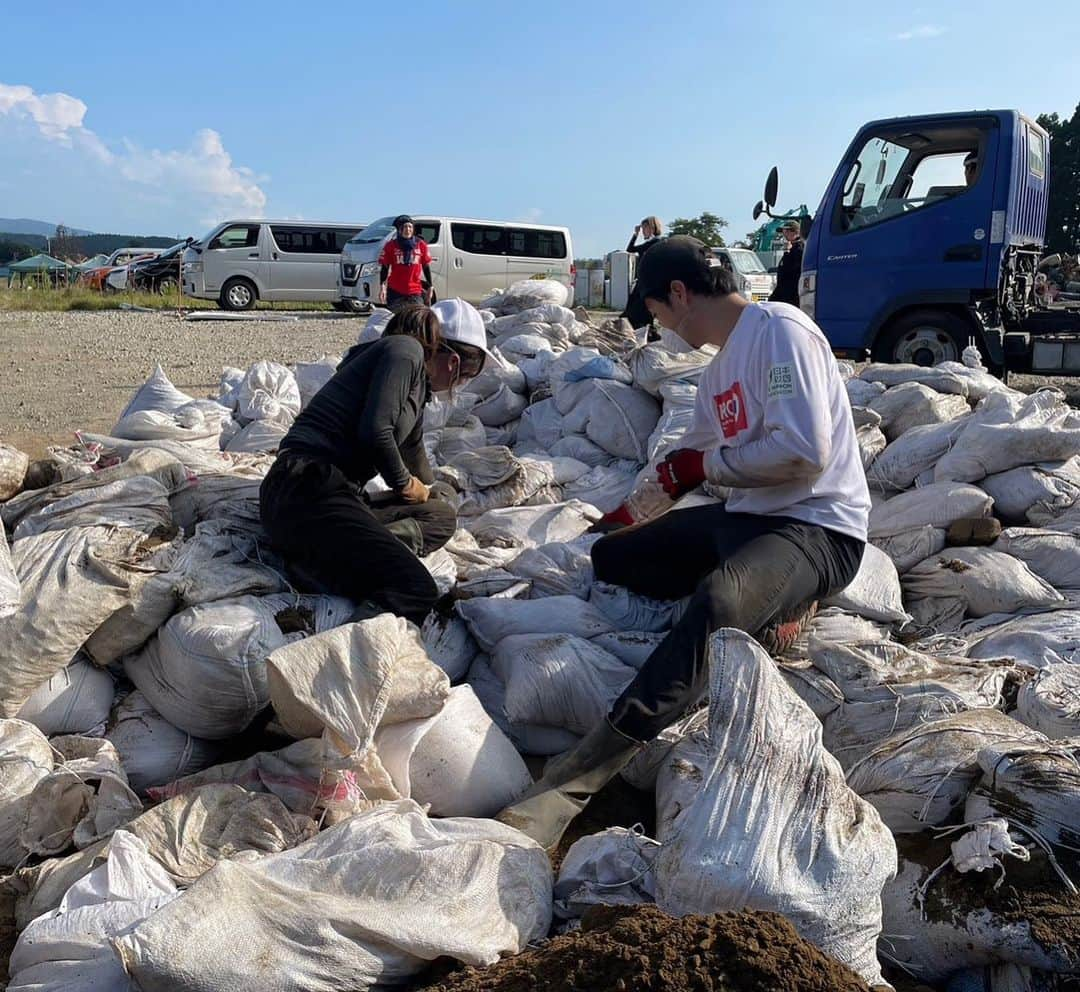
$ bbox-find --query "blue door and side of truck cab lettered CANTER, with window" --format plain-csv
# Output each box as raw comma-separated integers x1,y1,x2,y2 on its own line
816,121,998,348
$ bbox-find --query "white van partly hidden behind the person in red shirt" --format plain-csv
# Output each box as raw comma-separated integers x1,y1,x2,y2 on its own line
339,214,576,309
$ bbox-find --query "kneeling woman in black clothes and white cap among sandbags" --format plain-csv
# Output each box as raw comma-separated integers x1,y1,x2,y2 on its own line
259,300,486,624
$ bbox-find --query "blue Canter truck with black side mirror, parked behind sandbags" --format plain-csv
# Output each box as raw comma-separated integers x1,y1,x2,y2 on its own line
755,110,1080,375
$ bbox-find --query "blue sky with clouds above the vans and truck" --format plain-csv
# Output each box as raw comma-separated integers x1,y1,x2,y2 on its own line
0,0,1080,256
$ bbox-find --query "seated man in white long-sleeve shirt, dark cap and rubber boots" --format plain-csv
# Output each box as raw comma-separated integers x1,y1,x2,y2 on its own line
500,237,870,847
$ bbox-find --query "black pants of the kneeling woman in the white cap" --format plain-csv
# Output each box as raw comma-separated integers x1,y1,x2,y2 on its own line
259,452,457,624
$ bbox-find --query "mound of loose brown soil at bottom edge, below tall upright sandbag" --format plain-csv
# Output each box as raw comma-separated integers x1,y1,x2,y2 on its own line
428,906,868,992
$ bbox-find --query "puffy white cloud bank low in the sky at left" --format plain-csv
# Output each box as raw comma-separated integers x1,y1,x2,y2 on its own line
0,83,267,223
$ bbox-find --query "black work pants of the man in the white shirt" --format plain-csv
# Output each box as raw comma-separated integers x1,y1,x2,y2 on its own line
592,505,865,742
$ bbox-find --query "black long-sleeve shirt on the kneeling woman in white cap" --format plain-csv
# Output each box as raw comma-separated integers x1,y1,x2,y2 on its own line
280,335,435,490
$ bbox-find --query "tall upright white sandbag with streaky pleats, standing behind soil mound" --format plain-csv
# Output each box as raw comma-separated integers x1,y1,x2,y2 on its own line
656,628,896,984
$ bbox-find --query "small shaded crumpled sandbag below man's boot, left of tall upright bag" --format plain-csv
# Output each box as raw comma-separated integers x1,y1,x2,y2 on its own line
554,827,660,920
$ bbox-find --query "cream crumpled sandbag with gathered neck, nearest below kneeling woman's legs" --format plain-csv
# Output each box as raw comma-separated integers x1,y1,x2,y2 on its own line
268,613,450,756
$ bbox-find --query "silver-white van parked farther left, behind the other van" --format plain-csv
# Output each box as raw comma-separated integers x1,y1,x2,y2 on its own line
184,220,364,310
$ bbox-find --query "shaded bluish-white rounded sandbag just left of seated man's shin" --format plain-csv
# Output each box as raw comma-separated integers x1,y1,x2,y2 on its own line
491,634,636,734
